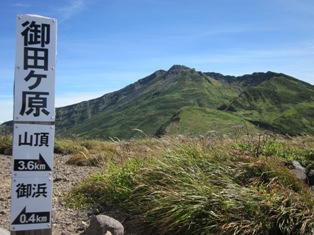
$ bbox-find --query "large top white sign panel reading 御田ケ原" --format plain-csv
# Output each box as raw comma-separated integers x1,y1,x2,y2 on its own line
14,15,57,122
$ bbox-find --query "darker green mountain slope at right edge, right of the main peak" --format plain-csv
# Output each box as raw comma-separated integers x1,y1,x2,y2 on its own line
226,74,314,135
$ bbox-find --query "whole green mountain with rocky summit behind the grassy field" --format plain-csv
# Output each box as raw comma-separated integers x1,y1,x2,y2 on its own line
0,65,314,139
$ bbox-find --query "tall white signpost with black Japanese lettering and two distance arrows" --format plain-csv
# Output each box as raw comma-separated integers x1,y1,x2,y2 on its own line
10,15,57,235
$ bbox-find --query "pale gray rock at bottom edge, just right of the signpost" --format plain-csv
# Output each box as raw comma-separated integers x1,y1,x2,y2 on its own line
84,215,124,235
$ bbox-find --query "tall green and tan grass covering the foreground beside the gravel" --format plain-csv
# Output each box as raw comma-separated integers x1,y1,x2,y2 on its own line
60,131,314,234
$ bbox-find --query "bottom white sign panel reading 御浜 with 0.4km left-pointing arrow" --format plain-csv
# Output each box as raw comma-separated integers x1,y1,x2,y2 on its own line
11,177,52,231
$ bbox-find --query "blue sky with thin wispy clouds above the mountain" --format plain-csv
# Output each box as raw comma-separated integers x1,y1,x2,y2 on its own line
0,0,314,122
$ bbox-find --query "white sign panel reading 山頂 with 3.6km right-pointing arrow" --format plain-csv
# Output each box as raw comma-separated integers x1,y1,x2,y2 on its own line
12,124,55,177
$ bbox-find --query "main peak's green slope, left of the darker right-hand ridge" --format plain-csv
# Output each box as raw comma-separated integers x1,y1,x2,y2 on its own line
57,66,239,138
